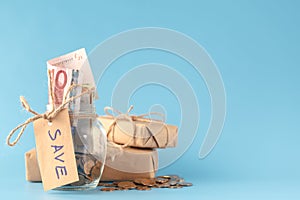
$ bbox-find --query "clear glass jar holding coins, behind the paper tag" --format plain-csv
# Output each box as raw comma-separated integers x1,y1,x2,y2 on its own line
50,96,107,190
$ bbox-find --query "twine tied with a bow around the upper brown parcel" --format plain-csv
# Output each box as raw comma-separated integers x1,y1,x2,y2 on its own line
104,105,169,148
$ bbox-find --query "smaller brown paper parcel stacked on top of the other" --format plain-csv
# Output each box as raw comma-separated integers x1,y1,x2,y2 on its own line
98,115,178,148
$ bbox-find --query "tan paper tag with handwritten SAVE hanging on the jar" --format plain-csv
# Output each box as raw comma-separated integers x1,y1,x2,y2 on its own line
33,109,79,191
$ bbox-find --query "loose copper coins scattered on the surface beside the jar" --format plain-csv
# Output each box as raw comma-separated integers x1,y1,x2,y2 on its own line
98,175,193,192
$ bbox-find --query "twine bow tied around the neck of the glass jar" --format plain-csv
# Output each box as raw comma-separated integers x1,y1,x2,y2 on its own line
6,72,95,146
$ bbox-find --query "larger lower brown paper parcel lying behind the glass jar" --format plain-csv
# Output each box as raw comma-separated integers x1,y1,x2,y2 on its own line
25,146,158,181
